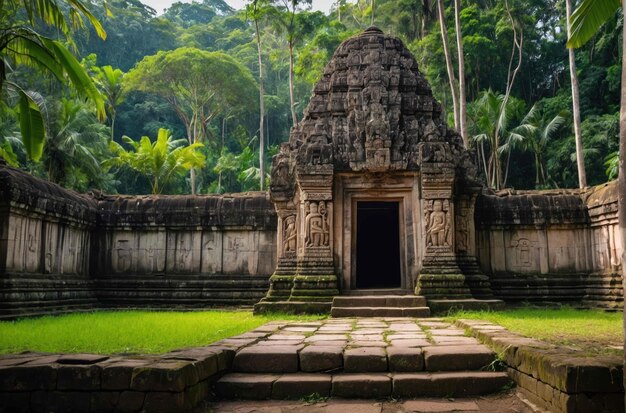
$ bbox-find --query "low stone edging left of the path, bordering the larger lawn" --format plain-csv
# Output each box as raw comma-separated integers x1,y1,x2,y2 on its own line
0,322,284,413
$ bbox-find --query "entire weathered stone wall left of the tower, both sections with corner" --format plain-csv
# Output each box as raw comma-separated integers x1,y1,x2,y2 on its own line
0,166,276,318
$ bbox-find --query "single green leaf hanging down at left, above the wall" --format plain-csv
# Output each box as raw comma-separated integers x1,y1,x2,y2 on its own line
17,89,46,162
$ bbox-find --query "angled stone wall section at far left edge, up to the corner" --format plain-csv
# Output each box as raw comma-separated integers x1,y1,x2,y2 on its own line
0,164,96,317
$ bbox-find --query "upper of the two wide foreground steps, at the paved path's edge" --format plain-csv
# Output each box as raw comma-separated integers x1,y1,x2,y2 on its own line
232,342,495,374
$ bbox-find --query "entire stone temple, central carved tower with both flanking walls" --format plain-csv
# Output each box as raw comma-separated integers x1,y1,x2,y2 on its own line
0,28,623,318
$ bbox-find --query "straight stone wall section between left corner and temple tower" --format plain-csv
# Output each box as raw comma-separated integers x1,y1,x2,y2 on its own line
92,192,276,307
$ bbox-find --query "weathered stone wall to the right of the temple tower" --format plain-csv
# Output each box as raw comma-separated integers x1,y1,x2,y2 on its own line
476,183,622,308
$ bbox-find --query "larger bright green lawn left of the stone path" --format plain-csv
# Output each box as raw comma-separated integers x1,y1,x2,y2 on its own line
0,311,325,354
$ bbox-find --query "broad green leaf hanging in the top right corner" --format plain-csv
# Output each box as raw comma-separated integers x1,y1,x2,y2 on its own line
567,0,621,48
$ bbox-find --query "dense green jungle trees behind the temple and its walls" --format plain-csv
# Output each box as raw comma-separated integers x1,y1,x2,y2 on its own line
0,0,623,193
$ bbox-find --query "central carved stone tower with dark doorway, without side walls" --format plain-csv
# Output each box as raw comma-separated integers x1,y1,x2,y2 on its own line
257,27,493,309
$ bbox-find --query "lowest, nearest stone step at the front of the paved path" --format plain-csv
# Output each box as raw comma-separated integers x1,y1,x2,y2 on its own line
215,371,511,400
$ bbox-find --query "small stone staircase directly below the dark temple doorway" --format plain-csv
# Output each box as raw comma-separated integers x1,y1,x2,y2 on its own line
330,295,430,317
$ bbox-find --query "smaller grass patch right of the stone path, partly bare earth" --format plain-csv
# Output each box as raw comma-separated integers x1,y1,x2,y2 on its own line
449,307,624,355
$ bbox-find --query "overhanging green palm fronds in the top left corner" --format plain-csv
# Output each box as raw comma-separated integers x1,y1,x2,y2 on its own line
0,0,106,161
